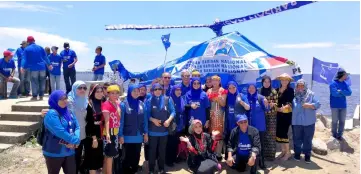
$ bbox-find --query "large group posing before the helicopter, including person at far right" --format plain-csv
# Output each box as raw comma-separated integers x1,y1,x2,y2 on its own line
39,66,351,174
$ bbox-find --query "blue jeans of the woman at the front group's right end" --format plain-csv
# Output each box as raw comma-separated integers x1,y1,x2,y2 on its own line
292,124,315,157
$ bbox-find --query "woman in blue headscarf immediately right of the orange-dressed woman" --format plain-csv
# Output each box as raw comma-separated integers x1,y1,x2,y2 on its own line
224,81,249,159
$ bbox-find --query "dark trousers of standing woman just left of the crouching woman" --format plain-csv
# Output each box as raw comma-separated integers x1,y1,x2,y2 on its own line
149,136,168,172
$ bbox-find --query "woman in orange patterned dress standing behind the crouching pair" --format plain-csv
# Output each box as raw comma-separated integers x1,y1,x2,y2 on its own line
207,75,228,160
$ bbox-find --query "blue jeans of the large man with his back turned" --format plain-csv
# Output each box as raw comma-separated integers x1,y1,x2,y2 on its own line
30,70,46,97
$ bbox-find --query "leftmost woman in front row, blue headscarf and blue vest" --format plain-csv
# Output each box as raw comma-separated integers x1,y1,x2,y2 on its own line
42,90,80,174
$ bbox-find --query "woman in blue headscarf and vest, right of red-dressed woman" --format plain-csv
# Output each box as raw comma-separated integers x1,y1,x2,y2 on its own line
118,85,148,174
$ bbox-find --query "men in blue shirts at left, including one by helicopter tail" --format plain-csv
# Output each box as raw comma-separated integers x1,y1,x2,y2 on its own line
0,36,106,100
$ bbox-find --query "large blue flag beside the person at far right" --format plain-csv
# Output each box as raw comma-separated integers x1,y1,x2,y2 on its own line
312,58,339,84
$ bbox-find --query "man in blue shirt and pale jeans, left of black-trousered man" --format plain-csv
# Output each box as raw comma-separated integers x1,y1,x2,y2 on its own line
48,46,62,90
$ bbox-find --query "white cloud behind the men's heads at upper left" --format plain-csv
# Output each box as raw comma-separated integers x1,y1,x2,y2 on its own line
0,27,93,70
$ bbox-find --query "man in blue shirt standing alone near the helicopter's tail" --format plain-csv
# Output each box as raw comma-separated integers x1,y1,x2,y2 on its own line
93,46,106,81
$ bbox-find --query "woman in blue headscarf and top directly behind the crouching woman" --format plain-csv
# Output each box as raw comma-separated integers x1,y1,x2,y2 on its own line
185,77,211,129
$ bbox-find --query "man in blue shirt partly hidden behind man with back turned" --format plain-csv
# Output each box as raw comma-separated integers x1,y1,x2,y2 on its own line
15,40,30,97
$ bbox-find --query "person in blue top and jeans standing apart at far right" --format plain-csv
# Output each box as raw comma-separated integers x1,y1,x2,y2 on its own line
330,69,352,140
